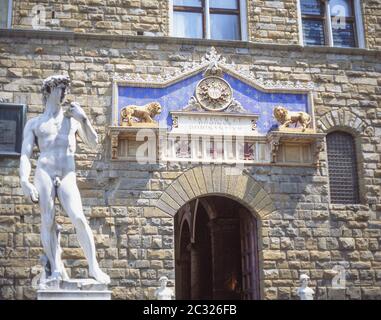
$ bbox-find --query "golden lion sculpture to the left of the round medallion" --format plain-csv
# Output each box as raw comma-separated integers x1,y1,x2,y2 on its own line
120,102,161,126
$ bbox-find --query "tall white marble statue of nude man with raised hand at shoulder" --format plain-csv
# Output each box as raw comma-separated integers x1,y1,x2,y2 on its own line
20,76,110,284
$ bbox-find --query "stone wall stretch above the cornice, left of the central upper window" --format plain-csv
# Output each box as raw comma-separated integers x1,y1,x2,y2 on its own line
13,0,169,35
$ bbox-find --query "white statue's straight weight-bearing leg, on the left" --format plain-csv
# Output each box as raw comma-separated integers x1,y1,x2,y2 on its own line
34,168,61,278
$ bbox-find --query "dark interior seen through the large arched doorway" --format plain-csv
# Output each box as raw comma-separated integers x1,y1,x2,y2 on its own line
175,196,259,300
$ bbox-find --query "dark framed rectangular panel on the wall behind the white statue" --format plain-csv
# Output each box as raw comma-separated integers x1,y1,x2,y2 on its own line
0,103,26,156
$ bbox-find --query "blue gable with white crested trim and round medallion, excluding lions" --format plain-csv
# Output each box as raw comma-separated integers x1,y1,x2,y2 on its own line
112,48,314,135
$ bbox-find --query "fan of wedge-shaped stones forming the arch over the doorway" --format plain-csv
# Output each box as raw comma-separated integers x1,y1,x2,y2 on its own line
157,165,276,219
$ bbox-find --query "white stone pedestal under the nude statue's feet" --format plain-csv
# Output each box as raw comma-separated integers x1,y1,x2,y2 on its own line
37,279,111,300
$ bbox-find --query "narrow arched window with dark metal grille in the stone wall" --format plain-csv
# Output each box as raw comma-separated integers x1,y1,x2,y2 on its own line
327,131,359,204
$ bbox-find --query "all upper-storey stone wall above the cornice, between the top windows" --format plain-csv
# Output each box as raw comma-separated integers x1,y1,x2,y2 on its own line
8,0,381,49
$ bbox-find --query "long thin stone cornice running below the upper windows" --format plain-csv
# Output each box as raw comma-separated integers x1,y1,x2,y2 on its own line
0,29,381,57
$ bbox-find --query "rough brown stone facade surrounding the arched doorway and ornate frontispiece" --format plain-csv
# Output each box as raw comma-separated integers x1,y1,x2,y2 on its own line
0,1,381,299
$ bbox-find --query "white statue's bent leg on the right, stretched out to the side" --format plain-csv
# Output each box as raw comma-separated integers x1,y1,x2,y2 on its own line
57,172,110,283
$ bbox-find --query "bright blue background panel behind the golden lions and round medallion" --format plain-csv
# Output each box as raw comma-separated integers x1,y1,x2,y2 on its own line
118,73,308,134
